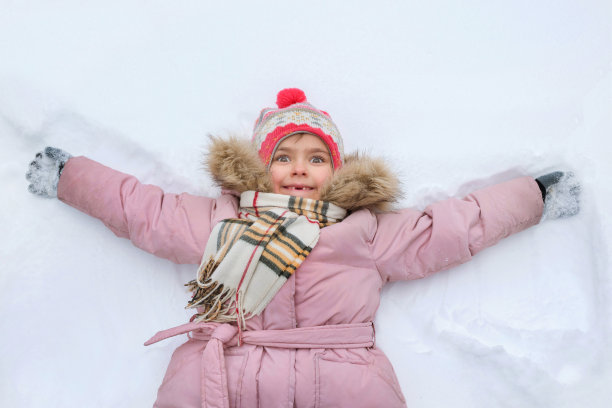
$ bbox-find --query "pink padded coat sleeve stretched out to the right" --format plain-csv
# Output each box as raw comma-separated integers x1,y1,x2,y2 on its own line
371,177,543,281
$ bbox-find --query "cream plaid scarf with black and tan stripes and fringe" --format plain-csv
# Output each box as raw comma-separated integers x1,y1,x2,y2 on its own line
185,191,346,328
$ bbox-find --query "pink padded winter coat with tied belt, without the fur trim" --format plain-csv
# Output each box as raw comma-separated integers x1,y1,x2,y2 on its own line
58,157,543,408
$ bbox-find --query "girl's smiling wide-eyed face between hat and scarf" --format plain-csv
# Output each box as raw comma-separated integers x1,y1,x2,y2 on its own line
270,133,333,200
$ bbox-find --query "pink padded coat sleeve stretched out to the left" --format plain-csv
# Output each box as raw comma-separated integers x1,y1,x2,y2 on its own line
58,157,237,264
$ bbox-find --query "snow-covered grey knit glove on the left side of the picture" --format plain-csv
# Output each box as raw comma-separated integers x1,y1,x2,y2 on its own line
26,147,72,198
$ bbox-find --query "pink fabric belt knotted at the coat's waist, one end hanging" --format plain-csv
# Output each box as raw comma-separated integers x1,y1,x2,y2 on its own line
145,322,375,408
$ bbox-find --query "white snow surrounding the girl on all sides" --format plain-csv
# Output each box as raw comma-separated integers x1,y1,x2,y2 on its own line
0,0,612,408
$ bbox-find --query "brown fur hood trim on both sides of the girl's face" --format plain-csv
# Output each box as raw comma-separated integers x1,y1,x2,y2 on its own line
204,136,400,211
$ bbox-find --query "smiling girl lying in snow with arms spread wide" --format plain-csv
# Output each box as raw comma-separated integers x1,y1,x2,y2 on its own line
26,89,580,407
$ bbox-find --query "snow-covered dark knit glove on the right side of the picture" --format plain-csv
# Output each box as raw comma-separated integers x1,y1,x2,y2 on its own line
536,171,582,219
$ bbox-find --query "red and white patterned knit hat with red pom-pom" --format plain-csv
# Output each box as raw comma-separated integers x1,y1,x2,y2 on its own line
253,88,344,169
